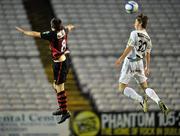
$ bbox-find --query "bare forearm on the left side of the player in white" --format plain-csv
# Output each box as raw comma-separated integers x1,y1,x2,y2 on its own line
115,46,133,67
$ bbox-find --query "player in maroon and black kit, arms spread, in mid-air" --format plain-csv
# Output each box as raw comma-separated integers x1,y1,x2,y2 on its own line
16,18,75,123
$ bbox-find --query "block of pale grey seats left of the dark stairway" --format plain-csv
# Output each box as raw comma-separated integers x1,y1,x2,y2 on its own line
0,0,53,110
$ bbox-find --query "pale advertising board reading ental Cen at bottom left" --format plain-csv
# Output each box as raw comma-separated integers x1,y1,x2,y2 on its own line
0,111,70,136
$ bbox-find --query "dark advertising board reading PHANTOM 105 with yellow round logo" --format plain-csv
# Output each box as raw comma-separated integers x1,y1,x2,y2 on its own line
70,111,180,136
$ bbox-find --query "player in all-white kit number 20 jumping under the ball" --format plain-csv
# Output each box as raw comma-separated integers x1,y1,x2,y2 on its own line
115,14,170,115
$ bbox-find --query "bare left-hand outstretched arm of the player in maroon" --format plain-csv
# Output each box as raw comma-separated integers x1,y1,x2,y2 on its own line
16,27,41,38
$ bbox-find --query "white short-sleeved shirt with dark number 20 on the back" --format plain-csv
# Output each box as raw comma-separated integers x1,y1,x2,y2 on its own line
127,30,152,59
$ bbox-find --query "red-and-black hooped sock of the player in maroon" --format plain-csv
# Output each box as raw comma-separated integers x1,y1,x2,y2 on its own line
57,91,67,113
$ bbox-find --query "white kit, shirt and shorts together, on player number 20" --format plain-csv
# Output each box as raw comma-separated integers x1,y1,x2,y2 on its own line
119,30,152,84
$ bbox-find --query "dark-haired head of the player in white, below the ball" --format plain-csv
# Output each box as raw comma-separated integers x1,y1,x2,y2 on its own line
134,14,148,29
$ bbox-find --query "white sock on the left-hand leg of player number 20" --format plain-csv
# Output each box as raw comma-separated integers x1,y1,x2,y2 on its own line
124,87,143,102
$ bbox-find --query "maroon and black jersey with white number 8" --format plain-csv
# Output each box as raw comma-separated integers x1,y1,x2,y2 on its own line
41,28,69,60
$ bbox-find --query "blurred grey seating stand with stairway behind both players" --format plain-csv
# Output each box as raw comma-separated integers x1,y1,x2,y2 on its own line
0,0,180,136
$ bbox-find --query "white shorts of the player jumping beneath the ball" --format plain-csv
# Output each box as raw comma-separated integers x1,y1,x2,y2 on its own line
119,58,147,84
